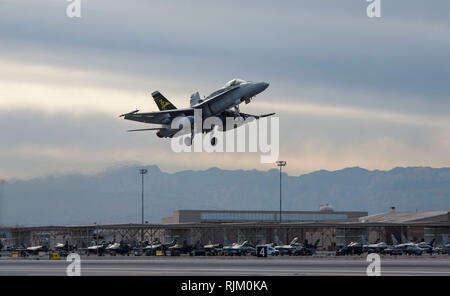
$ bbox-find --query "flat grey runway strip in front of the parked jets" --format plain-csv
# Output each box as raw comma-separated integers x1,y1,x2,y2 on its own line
0,256,450,276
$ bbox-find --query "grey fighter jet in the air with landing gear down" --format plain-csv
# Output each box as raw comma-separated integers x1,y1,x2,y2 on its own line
120,79,275,145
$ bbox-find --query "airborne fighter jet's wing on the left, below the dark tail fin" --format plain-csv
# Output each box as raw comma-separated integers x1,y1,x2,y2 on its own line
120,108,194,124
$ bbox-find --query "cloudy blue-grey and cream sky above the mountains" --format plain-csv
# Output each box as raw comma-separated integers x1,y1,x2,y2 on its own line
0,0,450,179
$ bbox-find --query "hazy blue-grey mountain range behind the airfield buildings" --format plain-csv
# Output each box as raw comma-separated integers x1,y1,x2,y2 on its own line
0,165,450,225
